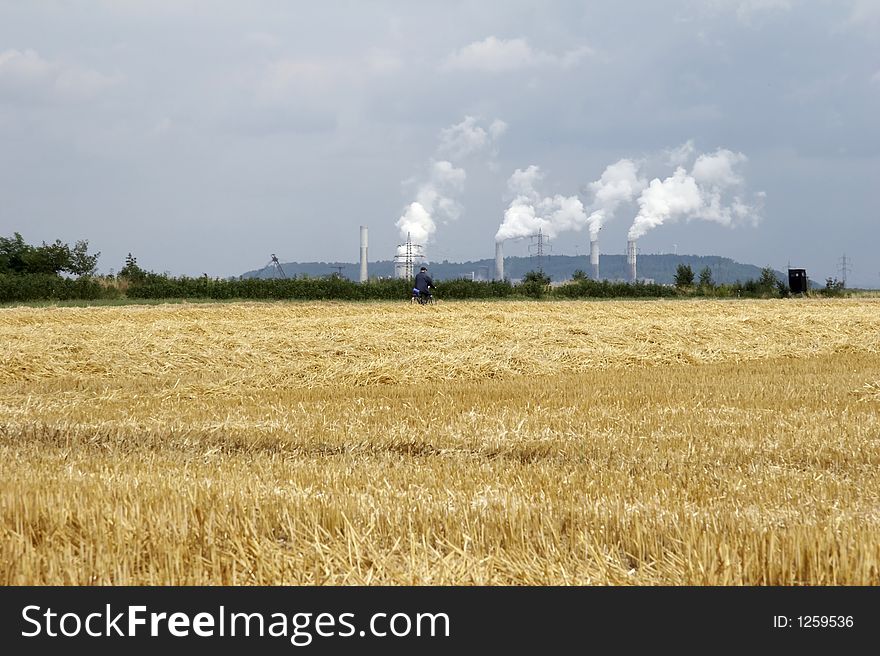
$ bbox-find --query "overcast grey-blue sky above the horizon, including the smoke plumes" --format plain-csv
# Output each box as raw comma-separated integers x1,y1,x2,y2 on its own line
0,0,880,287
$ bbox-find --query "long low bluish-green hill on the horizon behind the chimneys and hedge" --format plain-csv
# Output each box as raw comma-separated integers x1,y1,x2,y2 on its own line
241,254,788,284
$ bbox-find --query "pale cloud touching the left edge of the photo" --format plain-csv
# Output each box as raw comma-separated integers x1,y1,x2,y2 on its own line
0,49,123,100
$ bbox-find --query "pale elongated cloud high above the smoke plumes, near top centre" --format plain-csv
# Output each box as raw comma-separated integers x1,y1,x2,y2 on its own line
440,36,593,73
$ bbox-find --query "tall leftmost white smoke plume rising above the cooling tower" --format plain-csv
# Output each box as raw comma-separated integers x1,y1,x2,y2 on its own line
396,116,507,245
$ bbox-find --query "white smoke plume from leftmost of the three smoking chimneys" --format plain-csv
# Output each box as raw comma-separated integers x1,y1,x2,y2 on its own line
495,165,587,242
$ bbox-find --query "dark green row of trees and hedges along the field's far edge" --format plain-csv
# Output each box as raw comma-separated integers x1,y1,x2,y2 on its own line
0,233,843,303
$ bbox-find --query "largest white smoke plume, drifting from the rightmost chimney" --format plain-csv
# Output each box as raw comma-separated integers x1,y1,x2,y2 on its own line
628,142,764,239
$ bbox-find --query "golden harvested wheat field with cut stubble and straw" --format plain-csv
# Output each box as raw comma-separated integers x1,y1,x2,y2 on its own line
0,299,880,585
